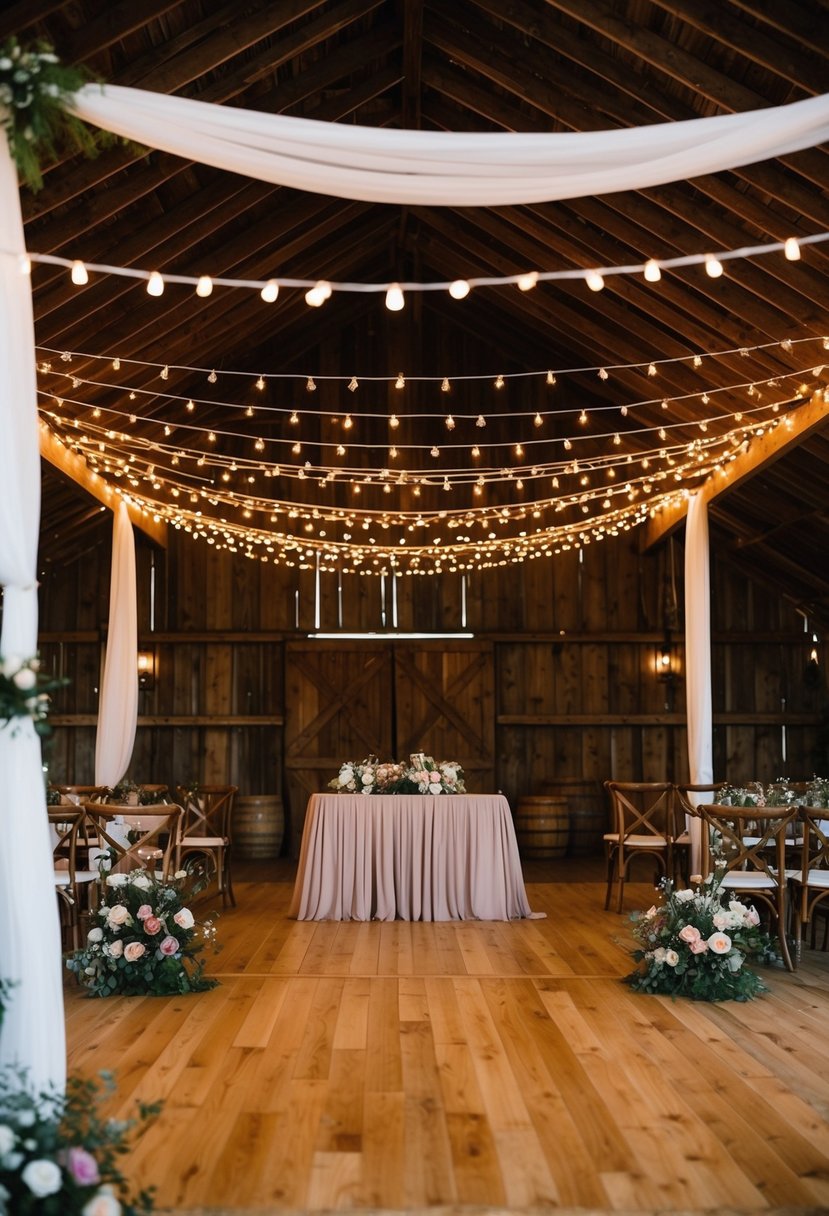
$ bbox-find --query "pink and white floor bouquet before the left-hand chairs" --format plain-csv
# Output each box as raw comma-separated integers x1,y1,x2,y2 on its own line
66,869,218,996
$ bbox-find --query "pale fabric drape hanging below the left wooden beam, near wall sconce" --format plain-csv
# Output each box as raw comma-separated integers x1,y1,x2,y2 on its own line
95,501,139,786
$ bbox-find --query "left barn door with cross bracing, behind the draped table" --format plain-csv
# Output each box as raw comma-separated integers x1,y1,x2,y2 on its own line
284,642,394,857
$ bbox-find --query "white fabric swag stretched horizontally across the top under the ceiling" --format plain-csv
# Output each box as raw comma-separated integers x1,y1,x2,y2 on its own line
74,85,829,207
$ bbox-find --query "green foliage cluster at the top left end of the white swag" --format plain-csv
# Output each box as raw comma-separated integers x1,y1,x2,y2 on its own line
0,36,106,190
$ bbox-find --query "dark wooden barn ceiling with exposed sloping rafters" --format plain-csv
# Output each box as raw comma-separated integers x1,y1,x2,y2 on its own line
6,0,829,625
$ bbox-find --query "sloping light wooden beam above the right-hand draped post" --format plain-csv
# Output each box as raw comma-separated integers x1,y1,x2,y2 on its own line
642,393,829,553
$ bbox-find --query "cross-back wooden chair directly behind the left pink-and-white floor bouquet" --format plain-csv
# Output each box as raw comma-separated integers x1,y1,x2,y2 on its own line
85,803,181,879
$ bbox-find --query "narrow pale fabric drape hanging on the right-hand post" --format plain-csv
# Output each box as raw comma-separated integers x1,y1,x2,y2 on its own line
686,494,714,873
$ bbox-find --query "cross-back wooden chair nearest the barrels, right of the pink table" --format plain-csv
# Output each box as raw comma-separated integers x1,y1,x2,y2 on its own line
604,781,676,912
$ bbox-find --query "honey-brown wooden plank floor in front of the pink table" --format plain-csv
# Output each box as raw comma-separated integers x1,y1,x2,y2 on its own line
66,863,829,1212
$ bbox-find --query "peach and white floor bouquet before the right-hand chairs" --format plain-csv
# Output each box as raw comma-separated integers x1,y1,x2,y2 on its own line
626,867,778,1001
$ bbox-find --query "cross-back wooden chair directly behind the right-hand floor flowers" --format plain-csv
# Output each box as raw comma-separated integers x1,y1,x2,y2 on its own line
699,803,799,972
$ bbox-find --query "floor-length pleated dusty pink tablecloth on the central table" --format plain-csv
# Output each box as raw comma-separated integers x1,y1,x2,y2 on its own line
288,794,532,921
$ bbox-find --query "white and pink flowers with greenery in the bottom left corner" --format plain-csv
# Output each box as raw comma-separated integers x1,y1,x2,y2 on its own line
0,1066,162,1216
